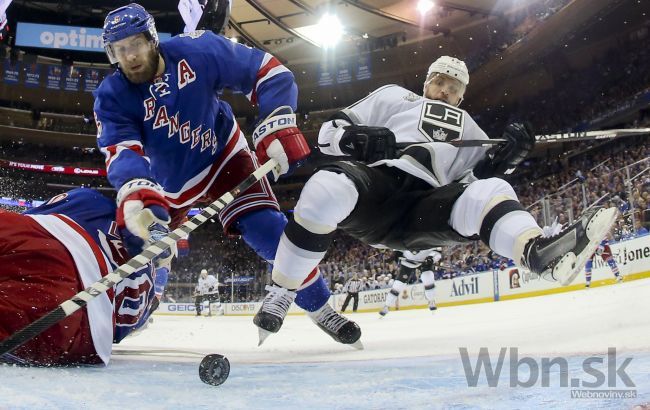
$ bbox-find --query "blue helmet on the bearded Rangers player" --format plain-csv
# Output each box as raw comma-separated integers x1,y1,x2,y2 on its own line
102,3,158,64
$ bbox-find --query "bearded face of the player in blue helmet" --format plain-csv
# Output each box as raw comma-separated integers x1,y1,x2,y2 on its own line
112,34,159,84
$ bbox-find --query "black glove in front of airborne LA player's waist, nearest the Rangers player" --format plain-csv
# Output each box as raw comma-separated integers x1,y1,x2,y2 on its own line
339,125,396,163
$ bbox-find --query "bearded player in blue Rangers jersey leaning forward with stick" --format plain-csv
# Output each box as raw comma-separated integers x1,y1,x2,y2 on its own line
94,3,361,343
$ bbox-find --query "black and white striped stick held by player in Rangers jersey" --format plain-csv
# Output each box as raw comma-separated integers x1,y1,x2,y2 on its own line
0,159,278,356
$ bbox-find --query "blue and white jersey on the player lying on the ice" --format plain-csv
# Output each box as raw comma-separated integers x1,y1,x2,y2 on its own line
25,188,155,348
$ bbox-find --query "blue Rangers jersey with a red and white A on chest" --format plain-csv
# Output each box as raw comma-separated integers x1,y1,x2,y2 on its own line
94,31,297,208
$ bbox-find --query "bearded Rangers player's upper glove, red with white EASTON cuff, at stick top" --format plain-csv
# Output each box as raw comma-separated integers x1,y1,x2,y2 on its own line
253,106,311,181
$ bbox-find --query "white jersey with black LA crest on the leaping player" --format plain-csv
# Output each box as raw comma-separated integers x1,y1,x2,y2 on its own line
318,85,489,187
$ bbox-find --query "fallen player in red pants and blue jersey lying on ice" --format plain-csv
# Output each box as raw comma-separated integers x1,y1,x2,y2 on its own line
0,188,164,365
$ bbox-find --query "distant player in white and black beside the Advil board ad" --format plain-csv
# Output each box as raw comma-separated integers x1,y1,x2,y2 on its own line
379,248,442,316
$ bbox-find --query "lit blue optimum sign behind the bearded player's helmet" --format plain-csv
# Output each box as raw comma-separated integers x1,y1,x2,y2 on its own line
16,22,171,53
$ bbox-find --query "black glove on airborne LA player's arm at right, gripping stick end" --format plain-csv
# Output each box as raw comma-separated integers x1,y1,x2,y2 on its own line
474,123,535,178
